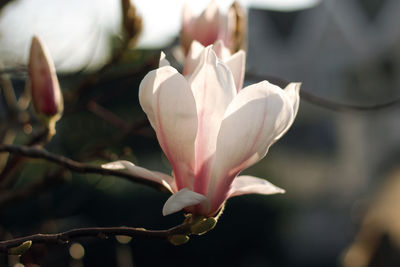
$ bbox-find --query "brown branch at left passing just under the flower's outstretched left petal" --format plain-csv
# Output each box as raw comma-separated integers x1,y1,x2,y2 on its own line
0,144,166,191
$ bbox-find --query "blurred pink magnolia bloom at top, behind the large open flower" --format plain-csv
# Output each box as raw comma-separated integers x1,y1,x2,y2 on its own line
181,0,247,54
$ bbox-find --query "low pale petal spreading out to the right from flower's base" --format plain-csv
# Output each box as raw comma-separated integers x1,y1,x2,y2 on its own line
228,175,285,198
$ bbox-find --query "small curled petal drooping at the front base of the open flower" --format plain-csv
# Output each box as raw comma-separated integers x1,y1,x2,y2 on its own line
162,188,208,216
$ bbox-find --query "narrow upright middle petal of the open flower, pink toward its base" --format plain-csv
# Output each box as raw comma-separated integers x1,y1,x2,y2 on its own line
189,46,236,194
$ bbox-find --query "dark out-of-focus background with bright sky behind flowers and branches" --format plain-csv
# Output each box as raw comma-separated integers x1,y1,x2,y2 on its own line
0,0,400,267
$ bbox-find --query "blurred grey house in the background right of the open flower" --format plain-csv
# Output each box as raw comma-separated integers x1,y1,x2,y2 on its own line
247,0,400,266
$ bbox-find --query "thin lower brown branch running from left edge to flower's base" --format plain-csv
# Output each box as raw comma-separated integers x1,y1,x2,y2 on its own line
0,223,190,253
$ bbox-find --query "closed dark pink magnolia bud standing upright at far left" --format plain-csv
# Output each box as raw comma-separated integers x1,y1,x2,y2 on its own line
29,36,63,128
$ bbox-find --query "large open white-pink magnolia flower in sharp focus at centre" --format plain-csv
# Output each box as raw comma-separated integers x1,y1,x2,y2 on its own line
103,45,300,217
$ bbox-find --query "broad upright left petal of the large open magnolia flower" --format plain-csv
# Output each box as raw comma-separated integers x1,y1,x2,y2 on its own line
139,66,197,191
